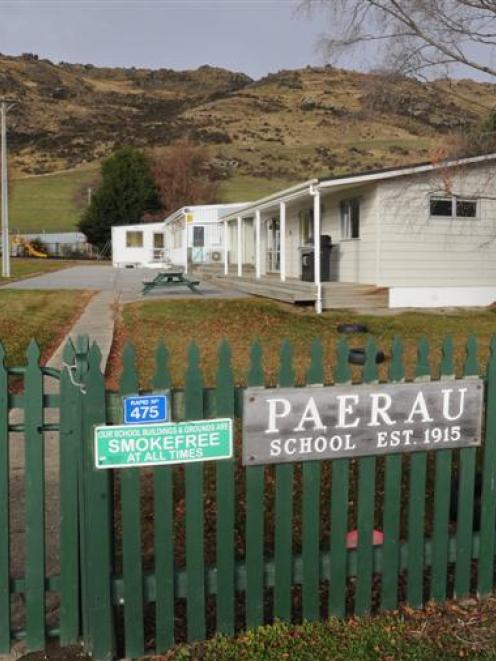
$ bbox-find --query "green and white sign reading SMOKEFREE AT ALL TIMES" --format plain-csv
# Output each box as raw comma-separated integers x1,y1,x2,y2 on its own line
95,418,233,468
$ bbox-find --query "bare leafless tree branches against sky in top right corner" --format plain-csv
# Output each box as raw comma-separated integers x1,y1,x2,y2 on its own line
301,0,496,77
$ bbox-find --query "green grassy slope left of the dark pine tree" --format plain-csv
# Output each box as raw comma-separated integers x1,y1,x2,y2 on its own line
10,166,97,233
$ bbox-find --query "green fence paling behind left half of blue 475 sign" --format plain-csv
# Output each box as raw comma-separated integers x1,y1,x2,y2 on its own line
120,345,145,658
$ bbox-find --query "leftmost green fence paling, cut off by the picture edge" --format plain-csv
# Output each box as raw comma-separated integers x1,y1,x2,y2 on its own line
0,343,10,654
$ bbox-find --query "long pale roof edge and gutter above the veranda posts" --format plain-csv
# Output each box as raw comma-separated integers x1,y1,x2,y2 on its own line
221,153,496,220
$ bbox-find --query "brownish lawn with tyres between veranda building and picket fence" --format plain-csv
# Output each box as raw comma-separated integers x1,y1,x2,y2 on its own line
111,299,496,386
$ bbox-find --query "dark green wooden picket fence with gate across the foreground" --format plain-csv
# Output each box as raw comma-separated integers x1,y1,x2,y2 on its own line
0,337,496,659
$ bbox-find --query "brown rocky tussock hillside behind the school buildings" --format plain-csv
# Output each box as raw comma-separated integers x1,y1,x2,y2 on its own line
0,55,496,228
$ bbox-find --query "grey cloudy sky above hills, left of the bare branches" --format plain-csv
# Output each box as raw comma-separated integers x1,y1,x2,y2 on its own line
0,0,492,79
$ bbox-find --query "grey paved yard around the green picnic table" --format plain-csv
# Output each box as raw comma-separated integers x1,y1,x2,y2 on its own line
0,265,247,303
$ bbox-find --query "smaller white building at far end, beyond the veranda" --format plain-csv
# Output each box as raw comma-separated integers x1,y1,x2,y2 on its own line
112,203,243,271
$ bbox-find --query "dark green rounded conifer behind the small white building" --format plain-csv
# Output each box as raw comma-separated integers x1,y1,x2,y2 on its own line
79,147,160,248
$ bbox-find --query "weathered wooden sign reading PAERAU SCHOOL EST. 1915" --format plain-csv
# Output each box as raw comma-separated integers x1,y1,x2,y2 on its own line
243,378,484,465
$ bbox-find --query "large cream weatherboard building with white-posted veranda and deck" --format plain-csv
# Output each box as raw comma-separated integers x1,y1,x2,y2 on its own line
222,154,496,312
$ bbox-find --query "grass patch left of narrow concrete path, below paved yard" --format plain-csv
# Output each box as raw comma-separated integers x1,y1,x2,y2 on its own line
0,290,92,365
